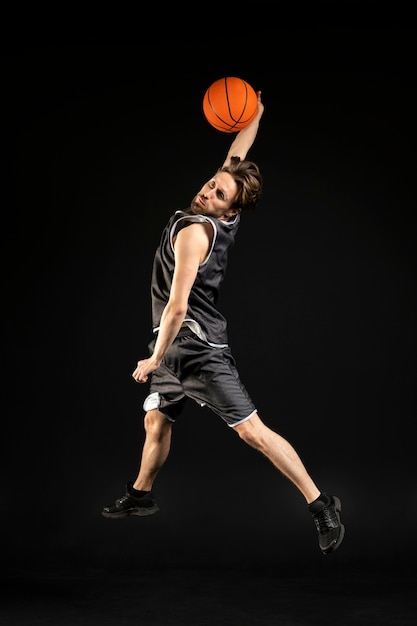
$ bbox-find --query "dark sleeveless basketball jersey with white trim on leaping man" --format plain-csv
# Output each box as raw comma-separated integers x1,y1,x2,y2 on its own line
151,209,240,347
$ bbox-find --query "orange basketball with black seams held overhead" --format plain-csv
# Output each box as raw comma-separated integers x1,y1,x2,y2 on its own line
203,76,258,133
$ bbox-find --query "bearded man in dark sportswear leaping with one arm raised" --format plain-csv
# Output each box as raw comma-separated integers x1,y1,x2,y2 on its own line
102,92,344,554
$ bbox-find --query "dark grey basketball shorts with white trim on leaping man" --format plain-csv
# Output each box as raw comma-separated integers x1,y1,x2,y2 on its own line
143,328,256,426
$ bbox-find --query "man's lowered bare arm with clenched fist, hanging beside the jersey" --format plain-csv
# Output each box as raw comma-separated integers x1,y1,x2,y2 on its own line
132,223,212,383
